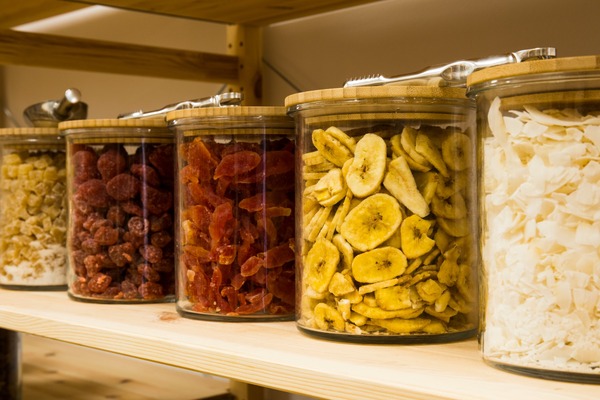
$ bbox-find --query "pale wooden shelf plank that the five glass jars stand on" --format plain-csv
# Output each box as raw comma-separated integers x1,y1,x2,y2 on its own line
0,289,598,400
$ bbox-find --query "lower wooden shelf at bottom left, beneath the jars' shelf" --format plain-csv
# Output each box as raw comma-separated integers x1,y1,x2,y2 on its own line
21,334,231,400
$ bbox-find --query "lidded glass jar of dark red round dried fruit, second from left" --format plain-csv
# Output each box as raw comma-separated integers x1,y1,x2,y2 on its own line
59,119,175,303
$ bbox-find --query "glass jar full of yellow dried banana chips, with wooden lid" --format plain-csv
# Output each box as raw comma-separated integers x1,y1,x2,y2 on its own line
285,86,478,343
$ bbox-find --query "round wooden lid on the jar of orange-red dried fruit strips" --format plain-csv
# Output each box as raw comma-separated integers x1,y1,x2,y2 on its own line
166,106,286,121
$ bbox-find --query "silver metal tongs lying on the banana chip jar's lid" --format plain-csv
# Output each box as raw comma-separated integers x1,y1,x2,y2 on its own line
344,47,556,87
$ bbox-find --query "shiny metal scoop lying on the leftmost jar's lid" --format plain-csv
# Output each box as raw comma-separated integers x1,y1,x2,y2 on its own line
23,89,87,127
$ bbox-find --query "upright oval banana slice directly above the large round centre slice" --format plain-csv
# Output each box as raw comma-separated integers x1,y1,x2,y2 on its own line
346,133,387,198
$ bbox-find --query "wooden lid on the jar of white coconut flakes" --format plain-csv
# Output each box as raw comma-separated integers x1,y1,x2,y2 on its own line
467,56,600,86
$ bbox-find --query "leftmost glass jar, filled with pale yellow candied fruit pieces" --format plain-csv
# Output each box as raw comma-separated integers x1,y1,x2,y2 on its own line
0,128,67,290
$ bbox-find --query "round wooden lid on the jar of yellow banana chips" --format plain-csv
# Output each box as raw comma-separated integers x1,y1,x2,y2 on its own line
285,85,466,107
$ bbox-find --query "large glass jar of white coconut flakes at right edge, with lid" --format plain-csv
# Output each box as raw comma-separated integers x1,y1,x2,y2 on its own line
468,56,600,383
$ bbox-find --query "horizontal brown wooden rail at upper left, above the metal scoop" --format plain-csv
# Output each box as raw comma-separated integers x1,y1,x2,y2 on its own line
0,30,238,83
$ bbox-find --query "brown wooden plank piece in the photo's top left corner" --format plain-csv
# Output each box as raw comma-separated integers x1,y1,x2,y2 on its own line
0,0,89,29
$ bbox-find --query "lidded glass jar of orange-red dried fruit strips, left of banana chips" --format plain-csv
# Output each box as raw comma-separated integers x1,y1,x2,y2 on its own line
167,107,295,321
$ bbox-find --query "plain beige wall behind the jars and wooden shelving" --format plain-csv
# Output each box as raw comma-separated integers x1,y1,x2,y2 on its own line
5,0,600,123
